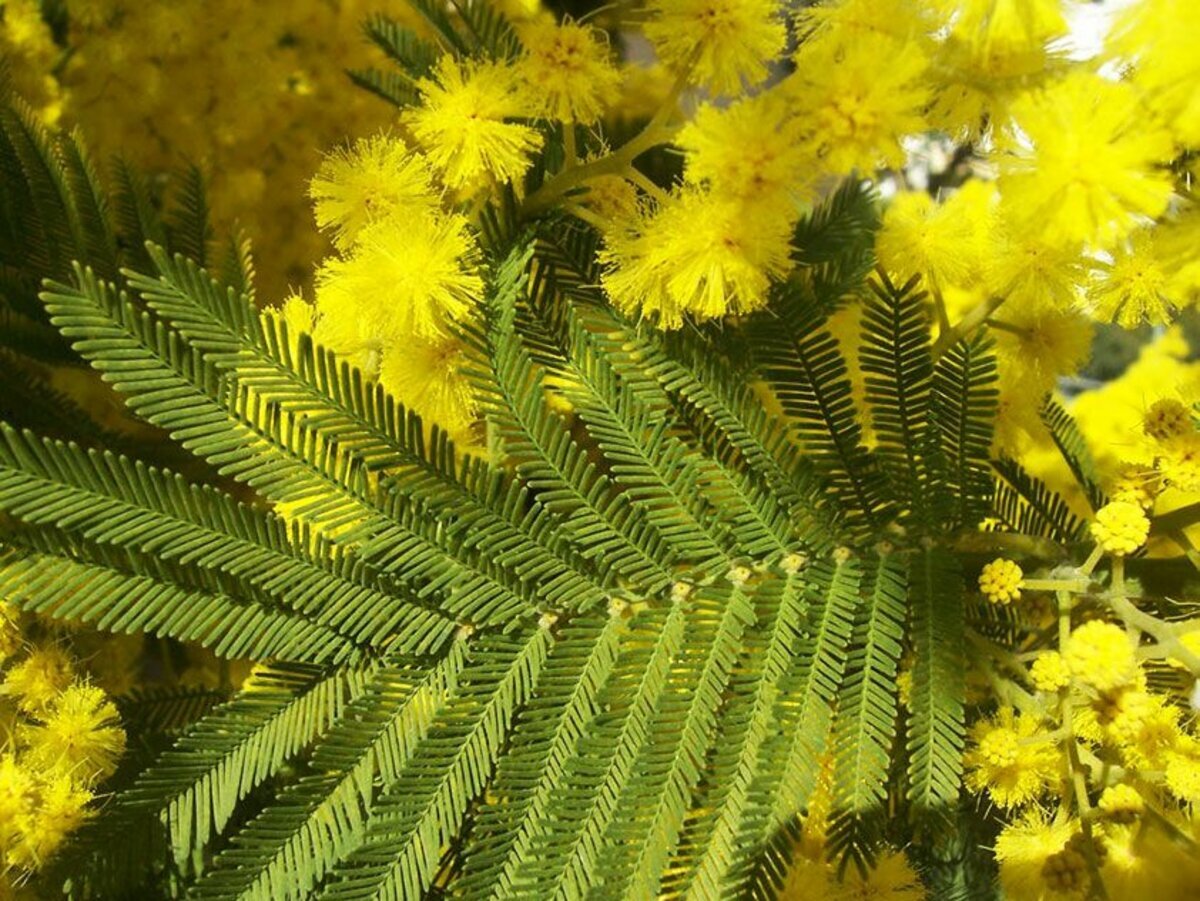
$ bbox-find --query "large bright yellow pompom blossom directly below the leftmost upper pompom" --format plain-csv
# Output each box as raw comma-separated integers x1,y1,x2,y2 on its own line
317,215,484,353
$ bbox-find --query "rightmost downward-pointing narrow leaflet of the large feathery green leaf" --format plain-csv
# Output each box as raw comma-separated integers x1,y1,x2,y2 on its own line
908,547,966,817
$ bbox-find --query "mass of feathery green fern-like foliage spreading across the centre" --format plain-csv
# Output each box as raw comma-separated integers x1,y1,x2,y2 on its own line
0,95,1090,899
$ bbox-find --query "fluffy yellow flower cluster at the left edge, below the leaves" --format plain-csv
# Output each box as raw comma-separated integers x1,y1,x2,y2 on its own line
0,605,125,888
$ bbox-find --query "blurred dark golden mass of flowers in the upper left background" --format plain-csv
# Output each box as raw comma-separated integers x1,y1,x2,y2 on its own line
0,0,436,298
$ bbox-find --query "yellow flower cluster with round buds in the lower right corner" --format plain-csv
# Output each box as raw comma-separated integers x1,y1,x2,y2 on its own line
964,547,1200,901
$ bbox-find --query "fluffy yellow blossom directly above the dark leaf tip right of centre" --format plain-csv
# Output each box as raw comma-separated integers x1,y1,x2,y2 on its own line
787,34,929,175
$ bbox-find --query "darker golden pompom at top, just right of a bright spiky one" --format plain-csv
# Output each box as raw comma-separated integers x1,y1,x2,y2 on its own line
517,19,620,125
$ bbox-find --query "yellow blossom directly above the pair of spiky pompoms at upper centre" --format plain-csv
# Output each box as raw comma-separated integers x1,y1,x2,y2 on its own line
676,91,814,211
